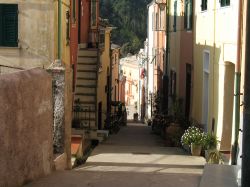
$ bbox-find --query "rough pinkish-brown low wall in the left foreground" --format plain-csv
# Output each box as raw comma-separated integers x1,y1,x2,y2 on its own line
0,69,53,187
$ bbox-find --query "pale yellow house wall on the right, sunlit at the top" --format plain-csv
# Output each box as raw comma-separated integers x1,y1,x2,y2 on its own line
192,0,238,150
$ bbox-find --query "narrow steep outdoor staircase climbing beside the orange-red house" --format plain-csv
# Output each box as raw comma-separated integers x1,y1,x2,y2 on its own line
74,45,98,130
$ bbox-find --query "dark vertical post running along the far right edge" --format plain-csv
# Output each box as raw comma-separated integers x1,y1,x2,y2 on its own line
241,1,250,187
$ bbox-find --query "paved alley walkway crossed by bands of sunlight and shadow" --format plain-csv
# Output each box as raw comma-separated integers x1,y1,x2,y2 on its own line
26,124,205,187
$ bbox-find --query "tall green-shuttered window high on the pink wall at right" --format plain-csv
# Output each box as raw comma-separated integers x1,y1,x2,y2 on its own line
184,0,193,30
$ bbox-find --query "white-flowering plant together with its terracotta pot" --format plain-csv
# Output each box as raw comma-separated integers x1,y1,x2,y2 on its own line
181,126,204,156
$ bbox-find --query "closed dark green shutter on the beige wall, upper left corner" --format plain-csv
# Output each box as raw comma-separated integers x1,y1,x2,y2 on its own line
0,4,18,47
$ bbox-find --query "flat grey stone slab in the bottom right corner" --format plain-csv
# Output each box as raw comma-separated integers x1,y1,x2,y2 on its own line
199,164,239,187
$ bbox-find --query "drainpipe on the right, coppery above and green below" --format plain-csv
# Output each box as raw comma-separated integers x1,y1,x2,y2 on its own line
231,1,242,165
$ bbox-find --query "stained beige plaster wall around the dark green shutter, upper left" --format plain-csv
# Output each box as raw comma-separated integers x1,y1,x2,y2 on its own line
0,0,54,68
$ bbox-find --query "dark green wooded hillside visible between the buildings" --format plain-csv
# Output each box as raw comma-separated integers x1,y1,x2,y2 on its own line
100,0,151,56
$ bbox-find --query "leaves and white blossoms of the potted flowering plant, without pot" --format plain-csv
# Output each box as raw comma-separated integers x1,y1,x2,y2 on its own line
181,126,205,146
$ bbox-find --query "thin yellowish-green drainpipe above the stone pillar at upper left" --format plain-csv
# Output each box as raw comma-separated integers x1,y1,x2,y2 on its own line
57,0,62,59
